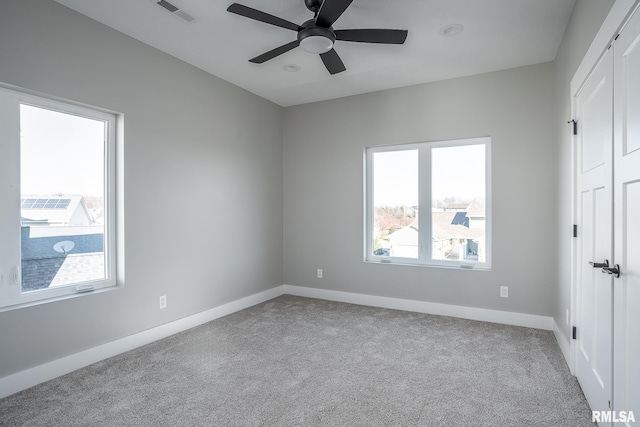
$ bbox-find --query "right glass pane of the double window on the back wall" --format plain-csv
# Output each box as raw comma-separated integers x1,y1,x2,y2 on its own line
431,144,486,262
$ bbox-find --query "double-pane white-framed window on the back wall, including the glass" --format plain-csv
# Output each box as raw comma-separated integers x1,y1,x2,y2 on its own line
365,138,491,269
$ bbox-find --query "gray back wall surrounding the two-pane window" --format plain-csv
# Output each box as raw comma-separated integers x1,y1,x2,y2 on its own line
284,63,557,316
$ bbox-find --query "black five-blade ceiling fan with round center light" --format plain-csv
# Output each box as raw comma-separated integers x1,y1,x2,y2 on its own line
227,0,408,74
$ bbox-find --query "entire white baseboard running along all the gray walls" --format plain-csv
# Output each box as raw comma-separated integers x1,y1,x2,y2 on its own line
0,285,556,398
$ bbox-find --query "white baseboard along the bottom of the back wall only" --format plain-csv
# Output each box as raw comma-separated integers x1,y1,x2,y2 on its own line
284,285,553,331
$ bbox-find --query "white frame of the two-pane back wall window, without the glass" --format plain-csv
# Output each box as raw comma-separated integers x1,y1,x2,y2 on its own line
364,136,492,270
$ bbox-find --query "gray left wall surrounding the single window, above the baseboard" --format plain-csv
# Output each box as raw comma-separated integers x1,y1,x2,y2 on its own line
0,0,283,376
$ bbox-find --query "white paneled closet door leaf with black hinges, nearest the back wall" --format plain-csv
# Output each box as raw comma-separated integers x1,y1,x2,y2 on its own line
576,50,613,427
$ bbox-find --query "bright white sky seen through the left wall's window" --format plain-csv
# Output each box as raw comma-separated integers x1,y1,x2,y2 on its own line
20,104,105,196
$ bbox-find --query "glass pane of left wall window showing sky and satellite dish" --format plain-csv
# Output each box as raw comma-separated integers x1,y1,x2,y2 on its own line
20,105,107,292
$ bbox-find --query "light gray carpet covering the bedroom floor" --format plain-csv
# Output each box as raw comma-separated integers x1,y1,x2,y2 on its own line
0,296,592,427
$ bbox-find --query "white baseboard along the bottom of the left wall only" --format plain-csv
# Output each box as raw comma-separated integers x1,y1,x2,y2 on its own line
0,286,284,398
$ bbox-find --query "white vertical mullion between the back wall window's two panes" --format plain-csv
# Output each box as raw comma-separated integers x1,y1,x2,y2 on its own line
418,144,432,264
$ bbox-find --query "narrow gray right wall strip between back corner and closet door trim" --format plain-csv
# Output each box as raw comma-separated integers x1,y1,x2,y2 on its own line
554,0,615,339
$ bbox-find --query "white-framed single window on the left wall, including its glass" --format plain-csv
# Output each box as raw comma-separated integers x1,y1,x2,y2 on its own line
0,88,116,308
